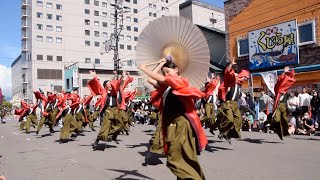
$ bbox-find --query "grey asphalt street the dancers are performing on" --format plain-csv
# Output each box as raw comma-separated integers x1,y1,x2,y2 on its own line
0,116,320,180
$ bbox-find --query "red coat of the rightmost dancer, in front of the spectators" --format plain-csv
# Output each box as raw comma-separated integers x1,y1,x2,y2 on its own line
273,69,296,111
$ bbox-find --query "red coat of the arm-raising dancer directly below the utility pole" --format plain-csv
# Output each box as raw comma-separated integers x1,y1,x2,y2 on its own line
87,76,120,112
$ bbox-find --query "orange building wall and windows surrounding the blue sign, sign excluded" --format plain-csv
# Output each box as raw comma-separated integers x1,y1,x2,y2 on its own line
224,0,320,90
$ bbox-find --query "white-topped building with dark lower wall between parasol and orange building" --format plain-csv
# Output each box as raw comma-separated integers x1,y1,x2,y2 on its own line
179,0,226,73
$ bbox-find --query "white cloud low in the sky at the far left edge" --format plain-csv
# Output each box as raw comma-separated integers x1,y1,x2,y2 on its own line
0,64,12,97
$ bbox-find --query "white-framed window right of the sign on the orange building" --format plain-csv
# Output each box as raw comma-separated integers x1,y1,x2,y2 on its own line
298,21,316,45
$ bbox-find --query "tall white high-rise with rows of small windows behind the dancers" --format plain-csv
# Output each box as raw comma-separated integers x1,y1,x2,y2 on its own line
11,0,180,101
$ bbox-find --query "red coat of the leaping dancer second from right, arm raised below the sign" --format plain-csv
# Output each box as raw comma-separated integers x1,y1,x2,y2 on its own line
218,68,250,101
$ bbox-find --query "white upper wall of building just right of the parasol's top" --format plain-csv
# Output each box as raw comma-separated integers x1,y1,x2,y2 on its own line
180,0,225,31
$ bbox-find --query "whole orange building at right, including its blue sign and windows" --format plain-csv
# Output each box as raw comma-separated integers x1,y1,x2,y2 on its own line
224,0,320,91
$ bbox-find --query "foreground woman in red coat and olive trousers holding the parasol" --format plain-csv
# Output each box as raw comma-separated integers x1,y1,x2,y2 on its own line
139,56,208,179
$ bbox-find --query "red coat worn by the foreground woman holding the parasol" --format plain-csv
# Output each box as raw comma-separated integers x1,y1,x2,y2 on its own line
151,75,208,154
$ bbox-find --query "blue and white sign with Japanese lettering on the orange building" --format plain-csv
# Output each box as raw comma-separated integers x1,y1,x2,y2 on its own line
248,20,299,70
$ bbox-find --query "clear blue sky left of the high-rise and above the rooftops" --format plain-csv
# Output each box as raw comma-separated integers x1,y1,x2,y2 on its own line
0,0,224,67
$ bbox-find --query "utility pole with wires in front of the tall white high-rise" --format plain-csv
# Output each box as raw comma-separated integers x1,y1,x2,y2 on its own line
101,0,129,78
